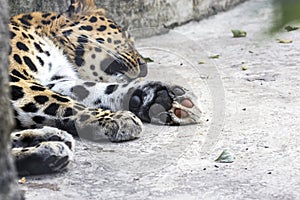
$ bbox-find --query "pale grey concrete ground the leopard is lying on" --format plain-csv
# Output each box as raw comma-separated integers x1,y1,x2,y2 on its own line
21,0,300,200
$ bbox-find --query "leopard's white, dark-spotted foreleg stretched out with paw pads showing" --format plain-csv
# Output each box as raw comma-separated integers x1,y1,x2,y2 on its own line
48,79,201,125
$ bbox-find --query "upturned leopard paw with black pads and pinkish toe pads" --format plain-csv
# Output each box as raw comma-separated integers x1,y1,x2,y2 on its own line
125,82,201,125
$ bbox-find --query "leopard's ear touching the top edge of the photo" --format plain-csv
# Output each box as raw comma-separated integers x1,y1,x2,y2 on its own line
67,0,105,17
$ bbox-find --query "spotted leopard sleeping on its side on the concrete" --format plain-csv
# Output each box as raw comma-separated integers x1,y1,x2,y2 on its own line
9,0,199,175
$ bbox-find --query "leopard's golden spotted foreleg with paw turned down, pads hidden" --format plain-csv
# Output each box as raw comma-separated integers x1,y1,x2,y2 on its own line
11,80,142,142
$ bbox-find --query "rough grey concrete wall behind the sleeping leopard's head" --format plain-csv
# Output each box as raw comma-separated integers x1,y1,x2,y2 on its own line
9,0,245,37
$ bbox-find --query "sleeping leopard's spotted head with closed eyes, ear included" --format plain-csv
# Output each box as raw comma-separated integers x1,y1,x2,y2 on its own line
57,0,147,82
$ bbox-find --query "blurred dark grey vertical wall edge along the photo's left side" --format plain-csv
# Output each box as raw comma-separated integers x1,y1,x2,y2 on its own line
0,0,21,200
